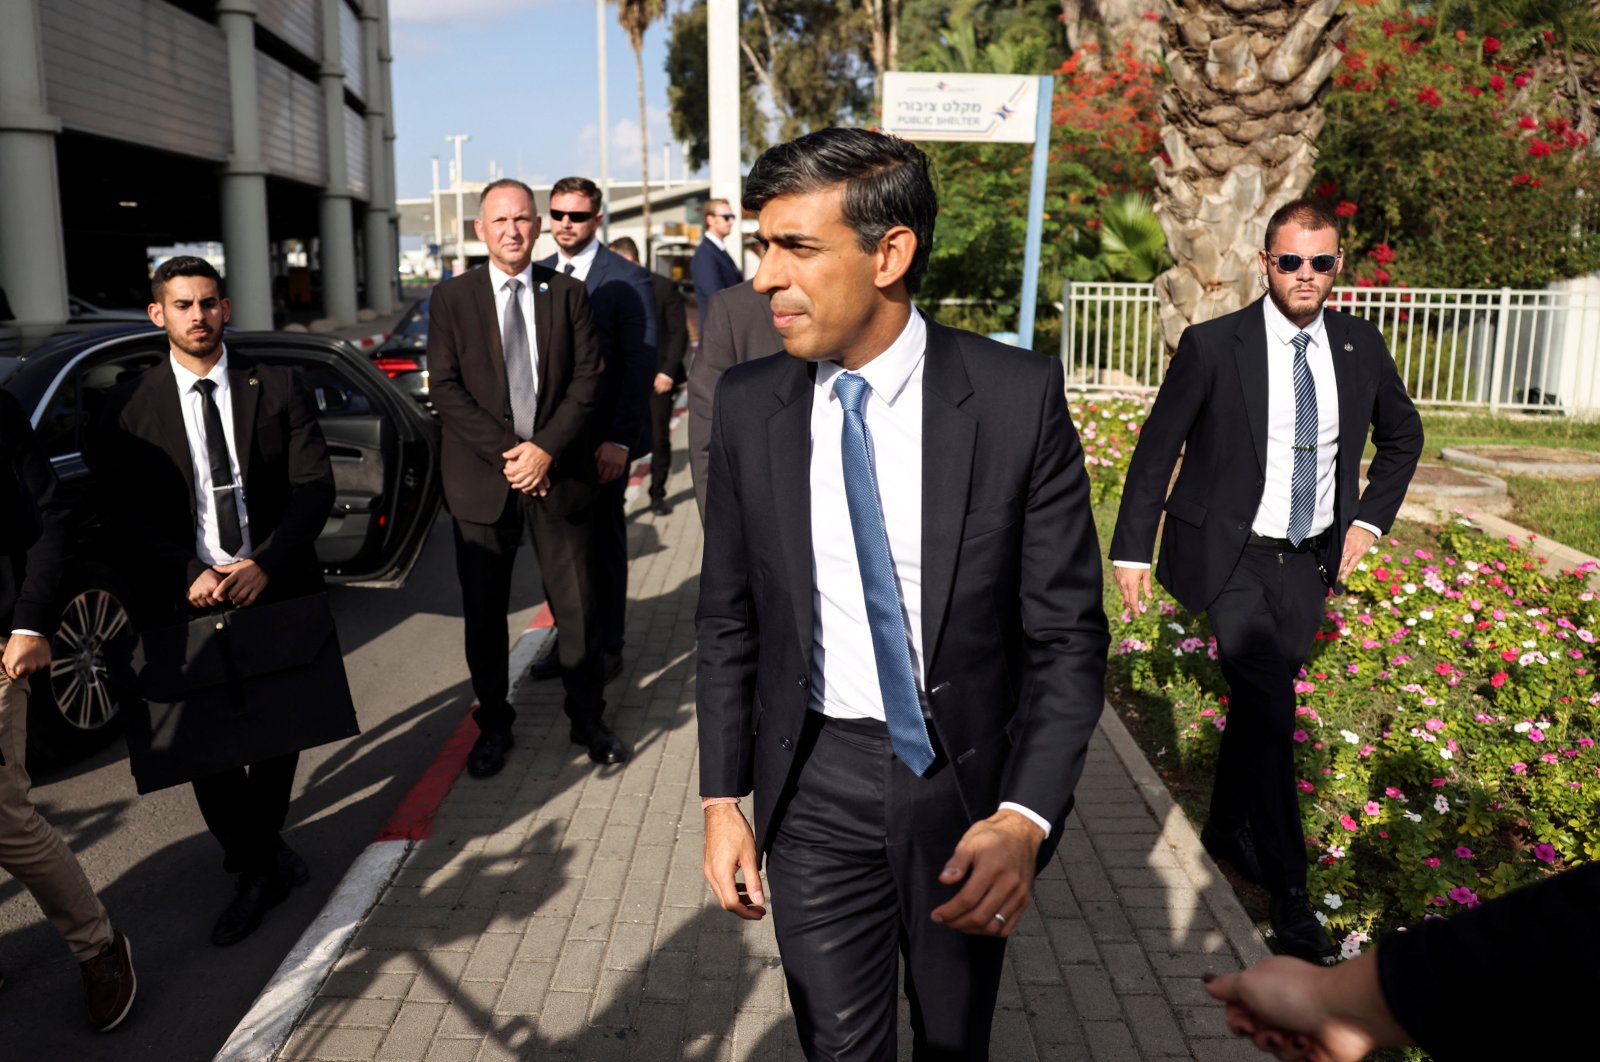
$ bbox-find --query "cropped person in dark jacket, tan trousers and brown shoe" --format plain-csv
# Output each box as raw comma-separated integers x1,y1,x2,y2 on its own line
0,390,138,1032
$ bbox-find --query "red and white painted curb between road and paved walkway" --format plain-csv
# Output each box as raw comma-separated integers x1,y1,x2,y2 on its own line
214,605,555,1062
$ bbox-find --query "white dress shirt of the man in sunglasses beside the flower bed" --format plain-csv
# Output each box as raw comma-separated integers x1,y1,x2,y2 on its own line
1112,299,1382,568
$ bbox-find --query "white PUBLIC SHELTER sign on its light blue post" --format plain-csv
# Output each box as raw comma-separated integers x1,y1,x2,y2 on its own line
883,70,1056,349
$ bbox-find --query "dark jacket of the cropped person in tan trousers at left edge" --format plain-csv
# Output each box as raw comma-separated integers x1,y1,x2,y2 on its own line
0,390,66,641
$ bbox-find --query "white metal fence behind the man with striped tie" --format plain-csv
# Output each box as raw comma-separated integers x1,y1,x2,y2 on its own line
1061,277,1600,416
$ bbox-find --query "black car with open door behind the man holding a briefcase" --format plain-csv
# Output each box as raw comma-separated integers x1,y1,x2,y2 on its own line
0,326,440,761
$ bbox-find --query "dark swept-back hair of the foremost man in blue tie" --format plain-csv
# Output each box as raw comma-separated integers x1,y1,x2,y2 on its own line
744,128,939,294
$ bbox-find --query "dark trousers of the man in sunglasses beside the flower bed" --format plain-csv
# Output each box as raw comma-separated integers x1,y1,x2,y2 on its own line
1206,545,1328,891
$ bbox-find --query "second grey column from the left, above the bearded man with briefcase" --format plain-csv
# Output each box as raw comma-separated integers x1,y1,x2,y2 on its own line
216,0,272,329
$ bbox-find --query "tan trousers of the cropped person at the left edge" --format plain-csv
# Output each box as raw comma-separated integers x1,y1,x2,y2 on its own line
0,658,112,963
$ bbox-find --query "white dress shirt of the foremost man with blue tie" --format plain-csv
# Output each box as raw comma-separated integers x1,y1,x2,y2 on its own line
810,310,1050,836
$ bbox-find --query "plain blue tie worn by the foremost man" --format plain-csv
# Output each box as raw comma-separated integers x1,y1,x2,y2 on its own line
834,373,933,776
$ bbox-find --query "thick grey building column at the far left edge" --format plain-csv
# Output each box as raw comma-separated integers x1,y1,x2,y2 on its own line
0,0,67,347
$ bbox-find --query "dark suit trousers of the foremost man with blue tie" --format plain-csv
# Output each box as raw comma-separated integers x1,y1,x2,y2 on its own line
766,712,1005,1062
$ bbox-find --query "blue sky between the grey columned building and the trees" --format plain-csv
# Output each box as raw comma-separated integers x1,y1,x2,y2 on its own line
389,0,683,198
